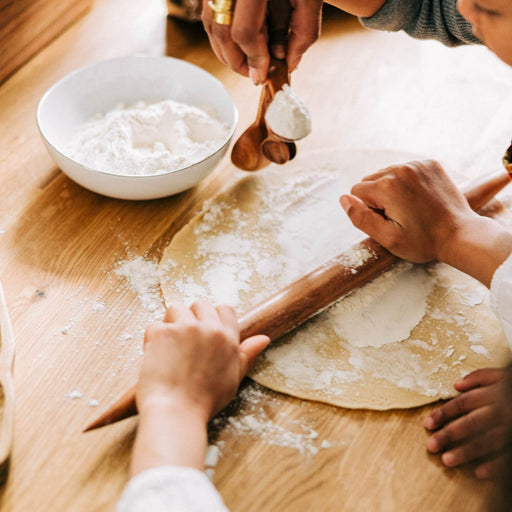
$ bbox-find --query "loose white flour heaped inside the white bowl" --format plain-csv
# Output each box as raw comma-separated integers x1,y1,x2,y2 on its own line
69,100,229,176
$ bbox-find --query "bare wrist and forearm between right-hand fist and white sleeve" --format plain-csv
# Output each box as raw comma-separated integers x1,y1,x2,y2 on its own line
439,216,512,287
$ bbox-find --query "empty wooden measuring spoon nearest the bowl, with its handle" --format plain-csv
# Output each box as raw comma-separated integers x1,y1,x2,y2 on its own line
231,85,272,171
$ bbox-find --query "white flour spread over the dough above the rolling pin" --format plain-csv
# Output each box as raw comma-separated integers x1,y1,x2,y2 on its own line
161,166,370,312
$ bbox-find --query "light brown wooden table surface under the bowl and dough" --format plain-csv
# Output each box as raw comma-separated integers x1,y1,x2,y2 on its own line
0,0,512,512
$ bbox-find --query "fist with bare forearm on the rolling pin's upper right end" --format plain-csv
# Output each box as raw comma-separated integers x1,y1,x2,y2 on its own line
340,160,512,287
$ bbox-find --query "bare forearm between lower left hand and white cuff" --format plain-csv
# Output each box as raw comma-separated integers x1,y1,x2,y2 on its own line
131,399,207,476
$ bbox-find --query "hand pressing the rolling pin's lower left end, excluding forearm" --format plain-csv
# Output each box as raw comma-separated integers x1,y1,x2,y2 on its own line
137,300,270,421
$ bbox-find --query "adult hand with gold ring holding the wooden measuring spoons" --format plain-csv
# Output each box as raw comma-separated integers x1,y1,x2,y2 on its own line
202,0,322,83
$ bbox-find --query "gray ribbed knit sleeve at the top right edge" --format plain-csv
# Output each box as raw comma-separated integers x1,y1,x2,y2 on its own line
359,0,481,46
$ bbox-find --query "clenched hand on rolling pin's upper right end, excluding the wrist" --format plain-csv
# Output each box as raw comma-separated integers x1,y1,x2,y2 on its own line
340,160,478,263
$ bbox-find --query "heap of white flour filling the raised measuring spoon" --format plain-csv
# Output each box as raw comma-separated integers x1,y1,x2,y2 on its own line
265,84,311,140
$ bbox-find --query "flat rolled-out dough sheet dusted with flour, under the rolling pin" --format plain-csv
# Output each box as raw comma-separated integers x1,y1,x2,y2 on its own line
160,151,509,409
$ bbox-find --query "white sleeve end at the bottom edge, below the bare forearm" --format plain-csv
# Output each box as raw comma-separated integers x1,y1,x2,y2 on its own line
116,466,228,512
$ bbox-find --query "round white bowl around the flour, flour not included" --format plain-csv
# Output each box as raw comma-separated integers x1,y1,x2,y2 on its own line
37,56,238,199
